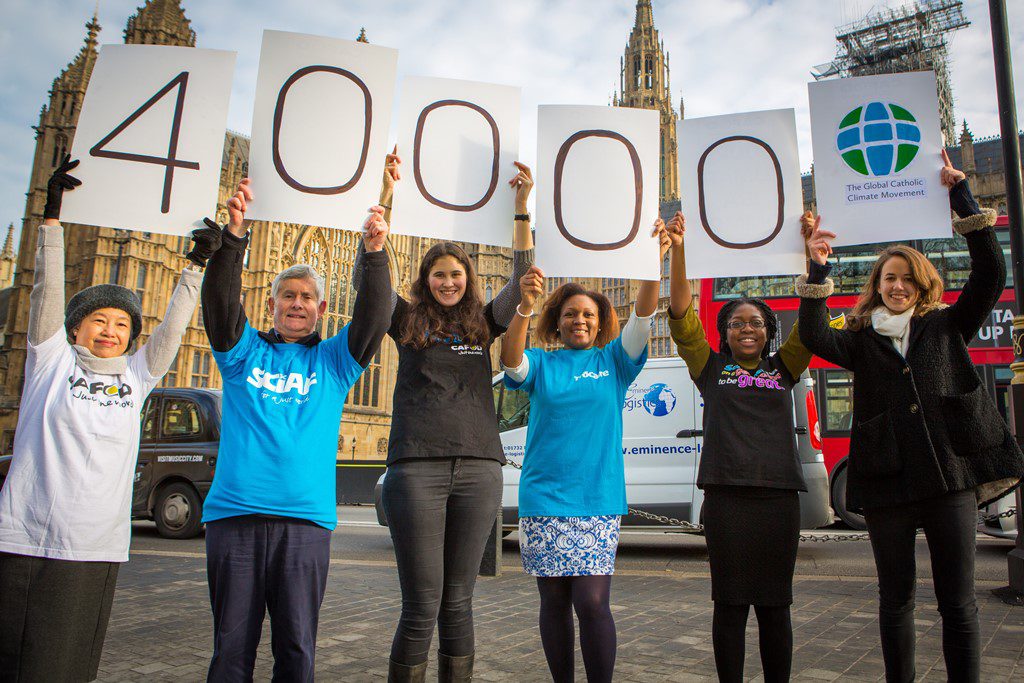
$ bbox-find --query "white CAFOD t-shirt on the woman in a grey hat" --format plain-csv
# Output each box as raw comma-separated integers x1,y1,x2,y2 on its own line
0,327,160,562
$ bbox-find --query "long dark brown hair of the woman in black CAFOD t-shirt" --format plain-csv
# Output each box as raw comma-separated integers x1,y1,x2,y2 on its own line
399,242,490,349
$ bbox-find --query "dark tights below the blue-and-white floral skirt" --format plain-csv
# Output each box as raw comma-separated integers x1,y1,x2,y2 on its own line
537,575,615,683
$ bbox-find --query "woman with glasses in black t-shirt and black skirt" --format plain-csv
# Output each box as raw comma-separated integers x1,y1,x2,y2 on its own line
669,213,811,683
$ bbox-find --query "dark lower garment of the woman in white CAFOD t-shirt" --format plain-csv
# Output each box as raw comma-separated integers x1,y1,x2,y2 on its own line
0,553,121,683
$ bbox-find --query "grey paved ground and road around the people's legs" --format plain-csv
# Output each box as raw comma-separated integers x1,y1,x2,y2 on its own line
98,508,1024,683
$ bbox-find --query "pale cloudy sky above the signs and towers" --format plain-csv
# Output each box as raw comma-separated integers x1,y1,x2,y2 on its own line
0,0,1024,240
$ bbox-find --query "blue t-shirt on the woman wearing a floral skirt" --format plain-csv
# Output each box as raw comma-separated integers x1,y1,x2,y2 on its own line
505,339,647,517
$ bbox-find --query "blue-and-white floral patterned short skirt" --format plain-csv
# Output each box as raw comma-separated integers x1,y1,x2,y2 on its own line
519,515,620,577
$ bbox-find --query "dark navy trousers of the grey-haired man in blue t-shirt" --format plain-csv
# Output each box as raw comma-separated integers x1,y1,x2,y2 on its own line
206,515,331,682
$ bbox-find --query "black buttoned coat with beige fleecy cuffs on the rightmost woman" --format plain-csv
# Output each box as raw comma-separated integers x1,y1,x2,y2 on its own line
797,213,1024,509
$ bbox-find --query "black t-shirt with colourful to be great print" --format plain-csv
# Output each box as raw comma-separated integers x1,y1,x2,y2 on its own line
697,351,807,490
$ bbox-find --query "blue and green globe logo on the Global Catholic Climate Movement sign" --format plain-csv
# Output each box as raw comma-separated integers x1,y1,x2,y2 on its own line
836,102,921,177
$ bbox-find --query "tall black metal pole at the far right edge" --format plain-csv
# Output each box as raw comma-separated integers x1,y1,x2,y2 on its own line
988,0,1024,604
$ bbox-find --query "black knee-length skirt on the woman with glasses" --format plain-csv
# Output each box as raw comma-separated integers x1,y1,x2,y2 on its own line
703,485,800,606
